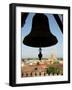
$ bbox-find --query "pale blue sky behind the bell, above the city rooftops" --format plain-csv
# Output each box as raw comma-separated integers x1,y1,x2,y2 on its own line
21,13,63,58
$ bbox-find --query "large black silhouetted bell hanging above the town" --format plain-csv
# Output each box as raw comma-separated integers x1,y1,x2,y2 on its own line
23,13,58,59
